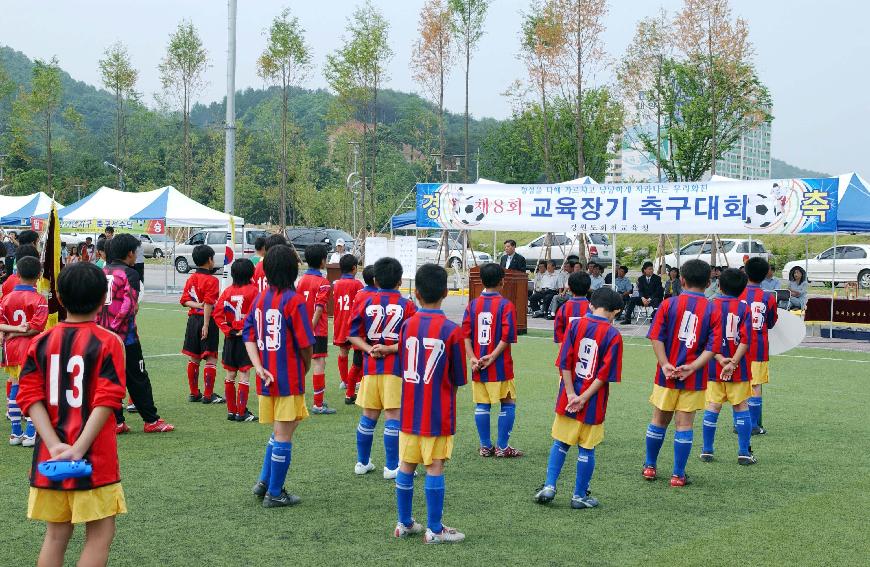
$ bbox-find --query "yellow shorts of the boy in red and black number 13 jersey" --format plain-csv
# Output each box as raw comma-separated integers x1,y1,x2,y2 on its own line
27,482,127,524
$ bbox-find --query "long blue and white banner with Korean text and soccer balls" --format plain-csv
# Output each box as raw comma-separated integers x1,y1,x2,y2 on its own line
417,177,840,234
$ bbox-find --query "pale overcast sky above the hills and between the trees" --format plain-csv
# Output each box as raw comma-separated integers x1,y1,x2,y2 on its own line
0,0,870,176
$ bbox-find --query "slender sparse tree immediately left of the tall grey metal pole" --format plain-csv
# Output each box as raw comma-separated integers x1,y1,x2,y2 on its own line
159,21,209,195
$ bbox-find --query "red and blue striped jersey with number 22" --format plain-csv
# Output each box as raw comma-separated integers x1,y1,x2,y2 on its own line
347,289,417,376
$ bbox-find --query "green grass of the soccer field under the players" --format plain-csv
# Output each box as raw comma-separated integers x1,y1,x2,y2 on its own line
0,304,870,567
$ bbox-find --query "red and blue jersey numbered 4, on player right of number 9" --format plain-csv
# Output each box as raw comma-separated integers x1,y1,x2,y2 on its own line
647,291,722,390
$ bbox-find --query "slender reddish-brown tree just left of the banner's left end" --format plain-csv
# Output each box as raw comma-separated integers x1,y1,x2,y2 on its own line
411,0,456,176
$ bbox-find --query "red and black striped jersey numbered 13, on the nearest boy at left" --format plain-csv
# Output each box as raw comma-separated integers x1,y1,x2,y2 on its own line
18,321,126,490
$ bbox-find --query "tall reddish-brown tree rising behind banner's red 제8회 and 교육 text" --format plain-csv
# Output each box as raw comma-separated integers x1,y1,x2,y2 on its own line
555,0,608,177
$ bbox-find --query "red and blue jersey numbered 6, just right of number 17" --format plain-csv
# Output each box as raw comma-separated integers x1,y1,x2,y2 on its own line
462,291,517,382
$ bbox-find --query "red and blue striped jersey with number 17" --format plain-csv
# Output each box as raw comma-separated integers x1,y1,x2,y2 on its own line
399,309,467,437
